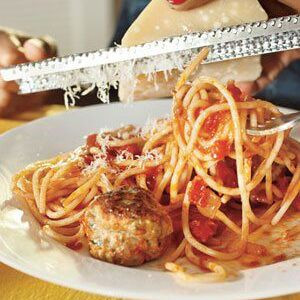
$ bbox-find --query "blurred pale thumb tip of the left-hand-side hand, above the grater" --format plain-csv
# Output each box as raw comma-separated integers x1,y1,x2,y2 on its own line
23,38,51,61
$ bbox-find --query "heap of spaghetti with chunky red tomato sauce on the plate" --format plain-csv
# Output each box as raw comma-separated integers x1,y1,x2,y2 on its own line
13,49,300,281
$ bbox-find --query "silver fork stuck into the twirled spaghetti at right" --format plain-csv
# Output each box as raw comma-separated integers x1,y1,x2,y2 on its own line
246,111,300,136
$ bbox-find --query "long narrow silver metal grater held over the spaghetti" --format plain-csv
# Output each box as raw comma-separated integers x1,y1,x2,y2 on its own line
0,15,300,94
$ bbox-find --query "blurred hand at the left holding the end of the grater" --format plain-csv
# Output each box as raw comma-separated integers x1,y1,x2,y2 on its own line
0,30,56,117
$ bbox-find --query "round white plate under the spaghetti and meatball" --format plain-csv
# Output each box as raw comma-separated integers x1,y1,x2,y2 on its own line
0,100,300,300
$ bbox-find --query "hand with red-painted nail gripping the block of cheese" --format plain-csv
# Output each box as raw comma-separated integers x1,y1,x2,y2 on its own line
166,0,300,94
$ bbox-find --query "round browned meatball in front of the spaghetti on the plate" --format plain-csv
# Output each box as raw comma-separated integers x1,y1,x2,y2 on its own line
83,187,173,266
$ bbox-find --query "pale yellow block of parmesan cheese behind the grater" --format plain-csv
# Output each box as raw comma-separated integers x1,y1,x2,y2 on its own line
119,0,268,101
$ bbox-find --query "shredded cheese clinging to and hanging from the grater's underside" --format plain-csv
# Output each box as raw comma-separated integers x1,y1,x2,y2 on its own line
55,50,197,109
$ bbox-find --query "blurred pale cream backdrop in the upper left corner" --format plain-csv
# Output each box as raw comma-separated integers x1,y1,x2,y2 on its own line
0,0,121,55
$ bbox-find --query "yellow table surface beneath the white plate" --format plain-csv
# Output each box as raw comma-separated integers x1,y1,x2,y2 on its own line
0,105,300,300
